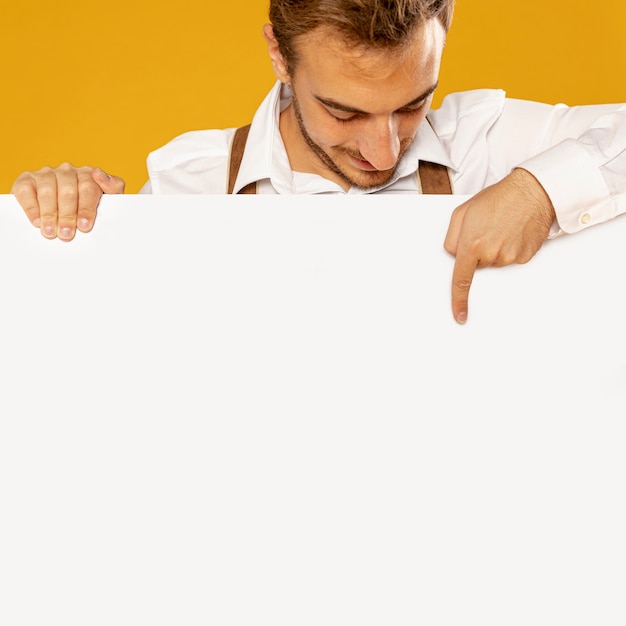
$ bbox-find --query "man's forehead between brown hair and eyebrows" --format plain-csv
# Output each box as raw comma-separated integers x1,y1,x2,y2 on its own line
292,19,445,112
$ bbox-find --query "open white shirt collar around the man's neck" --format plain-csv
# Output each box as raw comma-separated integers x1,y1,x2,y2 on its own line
234,81,457,193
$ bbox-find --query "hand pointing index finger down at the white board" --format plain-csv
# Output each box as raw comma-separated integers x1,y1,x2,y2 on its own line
444,169,555,324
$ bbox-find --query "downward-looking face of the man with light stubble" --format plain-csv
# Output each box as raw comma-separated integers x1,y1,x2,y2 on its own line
281,20,445,189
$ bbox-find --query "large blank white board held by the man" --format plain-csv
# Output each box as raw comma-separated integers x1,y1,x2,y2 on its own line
0,195,626,626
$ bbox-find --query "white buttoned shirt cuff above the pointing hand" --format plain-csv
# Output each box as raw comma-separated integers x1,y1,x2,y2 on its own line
518,139,613,236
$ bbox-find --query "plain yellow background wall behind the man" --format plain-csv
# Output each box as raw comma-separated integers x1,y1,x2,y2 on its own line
0,0,626,193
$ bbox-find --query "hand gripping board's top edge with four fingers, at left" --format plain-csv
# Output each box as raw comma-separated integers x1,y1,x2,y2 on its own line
11,163,125,241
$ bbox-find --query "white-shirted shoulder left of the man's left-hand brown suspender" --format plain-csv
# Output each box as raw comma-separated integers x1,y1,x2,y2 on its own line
147,128,235,193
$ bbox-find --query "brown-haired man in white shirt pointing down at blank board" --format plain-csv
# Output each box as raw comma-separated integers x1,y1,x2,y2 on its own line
13,0,626,323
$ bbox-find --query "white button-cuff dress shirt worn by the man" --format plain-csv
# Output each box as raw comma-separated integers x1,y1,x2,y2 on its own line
141,83,626,235
